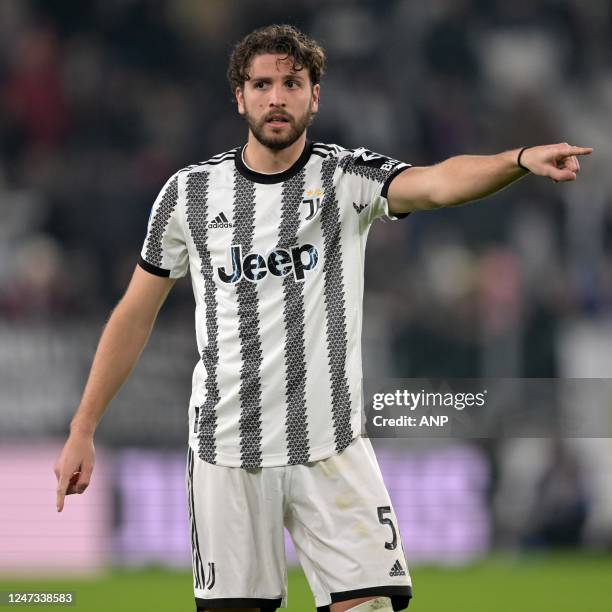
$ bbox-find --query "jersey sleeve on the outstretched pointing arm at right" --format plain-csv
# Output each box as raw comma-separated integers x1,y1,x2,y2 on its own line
341,147,410,229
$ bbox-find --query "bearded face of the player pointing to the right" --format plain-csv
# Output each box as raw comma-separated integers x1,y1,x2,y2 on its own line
236,53,319,151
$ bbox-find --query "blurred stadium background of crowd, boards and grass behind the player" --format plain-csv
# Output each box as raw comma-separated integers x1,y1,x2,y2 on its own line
0,0,612,612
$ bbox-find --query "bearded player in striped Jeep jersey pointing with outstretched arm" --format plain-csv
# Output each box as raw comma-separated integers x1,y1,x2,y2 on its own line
55,26,591,612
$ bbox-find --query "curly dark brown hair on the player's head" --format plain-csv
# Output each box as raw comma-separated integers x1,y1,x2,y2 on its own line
227,24,325,92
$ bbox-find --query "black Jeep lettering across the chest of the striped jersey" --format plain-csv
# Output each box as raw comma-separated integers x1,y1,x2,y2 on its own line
217,244,319,284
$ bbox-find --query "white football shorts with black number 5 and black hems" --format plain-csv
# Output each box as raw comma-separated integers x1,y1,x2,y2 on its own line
187,438,412,612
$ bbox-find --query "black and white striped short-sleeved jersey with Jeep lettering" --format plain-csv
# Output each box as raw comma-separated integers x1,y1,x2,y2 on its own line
140,142,409,468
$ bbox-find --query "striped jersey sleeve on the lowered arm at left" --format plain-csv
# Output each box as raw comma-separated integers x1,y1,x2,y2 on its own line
139,172,189,278
